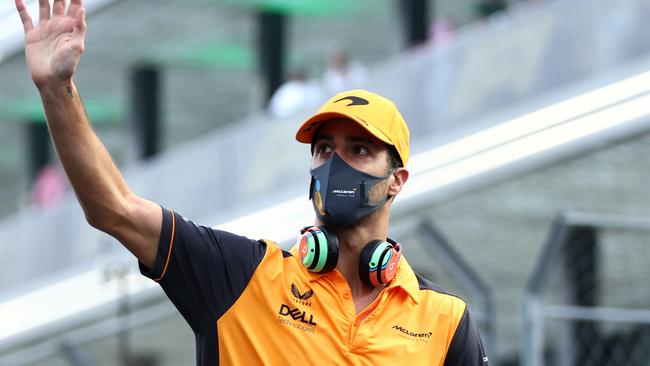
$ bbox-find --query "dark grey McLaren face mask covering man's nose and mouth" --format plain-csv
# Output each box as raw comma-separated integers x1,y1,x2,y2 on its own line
309,153,392,226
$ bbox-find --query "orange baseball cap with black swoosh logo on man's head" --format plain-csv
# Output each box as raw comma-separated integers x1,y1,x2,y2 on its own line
296,89,409,166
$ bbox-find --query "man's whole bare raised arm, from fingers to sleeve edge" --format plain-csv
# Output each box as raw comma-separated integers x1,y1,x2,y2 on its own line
15,0,162,268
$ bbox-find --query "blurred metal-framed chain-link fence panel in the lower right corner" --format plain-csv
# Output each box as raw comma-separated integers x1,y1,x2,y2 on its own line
521,214,650,366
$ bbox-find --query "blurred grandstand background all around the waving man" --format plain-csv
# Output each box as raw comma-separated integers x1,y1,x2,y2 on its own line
0,0,650,366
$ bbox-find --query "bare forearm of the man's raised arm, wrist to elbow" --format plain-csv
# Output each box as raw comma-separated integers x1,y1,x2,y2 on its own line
39,80,132,231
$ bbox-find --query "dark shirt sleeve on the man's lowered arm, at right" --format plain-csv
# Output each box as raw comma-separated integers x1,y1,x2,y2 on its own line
444,308,488,366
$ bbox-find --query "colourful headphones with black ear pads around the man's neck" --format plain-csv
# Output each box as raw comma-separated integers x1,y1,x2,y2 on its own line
298,226,402,287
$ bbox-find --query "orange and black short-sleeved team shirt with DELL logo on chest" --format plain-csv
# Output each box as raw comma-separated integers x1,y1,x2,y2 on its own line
140,209,488,366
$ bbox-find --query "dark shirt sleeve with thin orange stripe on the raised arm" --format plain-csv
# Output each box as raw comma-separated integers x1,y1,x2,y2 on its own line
139,208,266,332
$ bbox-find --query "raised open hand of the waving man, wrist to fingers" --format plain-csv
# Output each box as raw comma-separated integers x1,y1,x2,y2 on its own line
15,0,86,86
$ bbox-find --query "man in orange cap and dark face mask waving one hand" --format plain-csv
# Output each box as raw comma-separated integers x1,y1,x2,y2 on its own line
16,0,487,365
